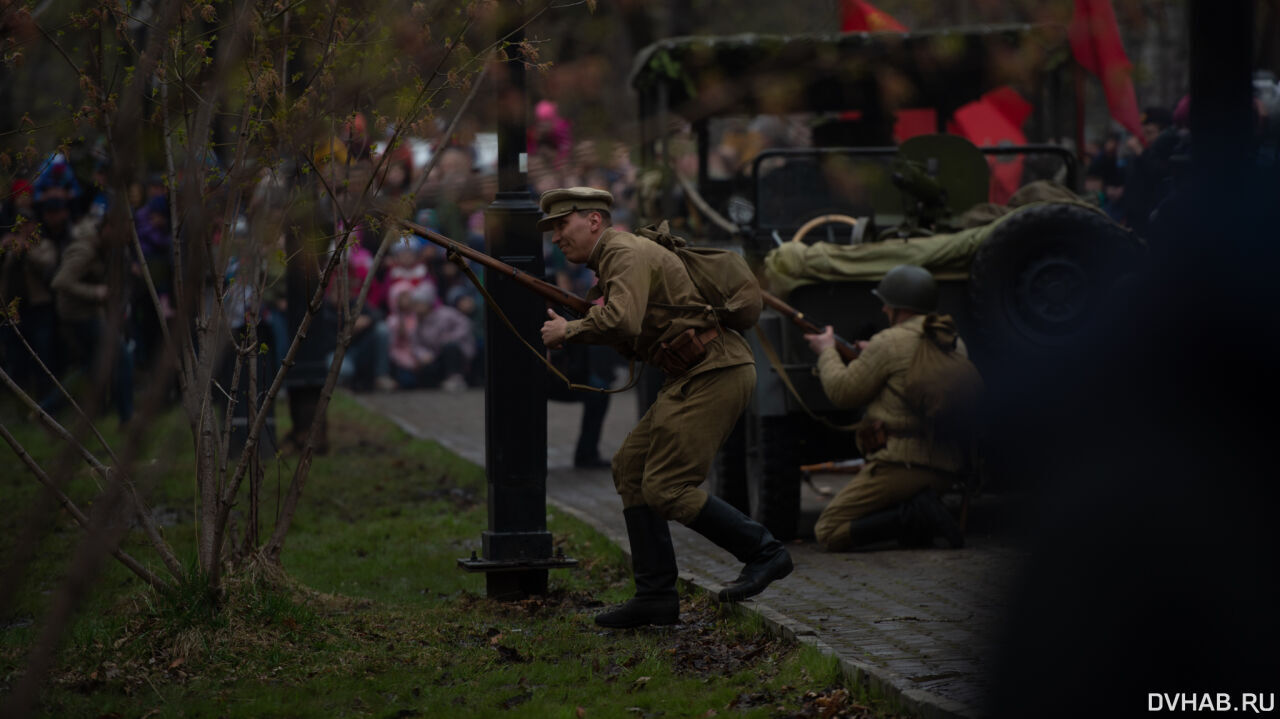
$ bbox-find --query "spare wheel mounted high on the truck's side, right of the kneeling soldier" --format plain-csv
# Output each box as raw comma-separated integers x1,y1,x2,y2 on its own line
969,203,1142,356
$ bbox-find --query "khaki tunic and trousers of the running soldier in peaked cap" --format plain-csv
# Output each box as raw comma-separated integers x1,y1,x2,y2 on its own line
564,228,755,525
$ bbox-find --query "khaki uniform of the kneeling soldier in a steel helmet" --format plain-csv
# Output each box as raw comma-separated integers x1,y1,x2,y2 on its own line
814,315,968,551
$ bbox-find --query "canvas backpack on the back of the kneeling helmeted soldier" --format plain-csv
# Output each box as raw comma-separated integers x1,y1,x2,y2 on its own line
904,313,983,440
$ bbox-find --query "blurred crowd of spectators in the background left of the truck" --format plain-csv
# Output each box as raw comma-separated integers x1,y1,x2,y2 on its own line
0,101,635,422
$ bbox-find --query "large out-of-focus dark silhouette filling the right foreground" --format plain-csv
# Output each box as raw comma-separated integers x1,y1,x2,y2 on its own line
988,0,1280,718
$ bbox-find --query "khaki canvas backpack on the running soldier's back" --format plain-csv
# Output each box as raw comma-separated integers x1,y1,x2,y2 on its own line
636,220,764,331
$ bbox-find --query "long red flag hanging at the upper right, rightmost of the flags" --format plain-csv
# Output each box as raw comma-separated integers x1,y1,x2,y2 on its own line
1070,0,1142,139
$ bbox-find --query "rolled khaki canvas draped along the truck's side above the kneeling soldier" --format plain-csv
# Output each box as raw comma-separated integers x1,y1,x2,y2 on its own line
764,182,1101,297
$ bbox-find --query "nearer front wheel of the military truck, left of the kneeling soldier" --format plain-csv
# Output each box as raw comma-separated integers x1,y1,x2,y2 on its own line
746,417,800,541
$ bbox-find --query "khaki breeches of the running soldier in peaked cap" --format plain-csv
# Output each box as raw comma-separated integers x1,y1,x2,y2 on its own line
613,365,755,525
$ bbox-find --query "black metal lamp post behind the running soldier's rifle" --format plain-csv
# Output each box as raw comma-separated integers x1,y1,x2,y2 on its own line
460,17,576,599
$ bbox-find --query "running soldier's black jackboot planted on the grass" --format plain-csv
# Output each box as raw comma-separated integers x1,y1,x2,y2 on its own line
595,505,680,629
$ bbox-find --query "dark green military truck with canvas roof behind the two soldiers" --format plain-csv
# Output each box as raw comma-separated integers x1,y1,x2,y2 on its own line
631,26,1142,537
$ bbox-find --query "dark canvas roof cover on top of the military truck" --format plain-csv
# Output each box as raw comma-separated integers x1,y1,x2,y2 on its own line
631,24,1069,122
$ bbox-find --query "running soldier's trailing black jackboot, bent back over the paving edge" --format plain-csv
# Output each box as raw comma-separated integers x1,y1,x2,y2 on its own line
689,496,794,601
